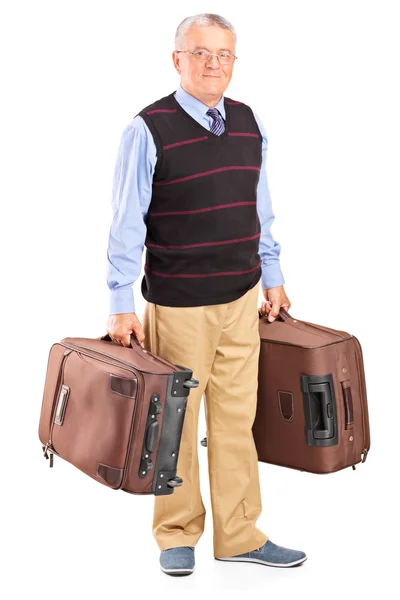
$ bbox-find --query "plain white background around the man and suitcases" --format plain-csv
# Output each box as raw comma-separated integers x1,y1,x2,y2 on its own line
0,0,400,600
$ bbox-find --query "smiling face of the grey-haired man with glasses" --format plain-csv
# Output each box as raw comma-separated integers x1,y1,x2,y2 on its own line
172,25,236,101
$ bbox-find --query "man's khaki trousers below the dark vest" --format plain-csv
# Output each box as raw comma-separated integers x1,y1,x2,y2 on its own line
142,282,268,558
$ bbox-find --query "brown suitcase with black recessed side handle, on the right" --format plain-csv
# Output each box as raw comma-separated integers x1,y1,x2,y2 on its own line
201,309,371,473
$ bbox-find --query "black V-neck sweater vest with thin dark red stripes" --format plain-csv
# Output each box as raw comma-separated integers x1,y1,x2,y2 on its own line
138,92,262,306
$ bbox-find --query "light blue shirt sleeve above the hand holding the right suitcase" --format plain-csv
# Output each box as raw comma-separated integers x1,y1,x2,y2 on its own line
253,111,285,290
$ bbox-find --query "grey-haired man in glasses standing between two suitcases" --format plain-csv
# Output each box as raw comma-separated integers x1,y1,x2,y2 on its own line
107,14,307,575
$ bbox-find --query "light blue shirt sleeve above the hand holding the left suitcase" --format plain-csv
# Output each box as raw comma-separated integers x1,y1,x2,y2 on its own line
107,115,157,315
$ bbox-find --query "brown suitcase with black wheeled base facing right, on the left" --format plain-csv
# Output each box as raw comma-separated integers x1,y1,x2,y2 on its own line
39,334,199,496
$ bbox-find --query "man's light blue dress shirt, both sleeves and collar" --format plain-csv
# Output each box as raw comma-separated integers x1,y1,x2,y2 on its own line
107,85,285,315
